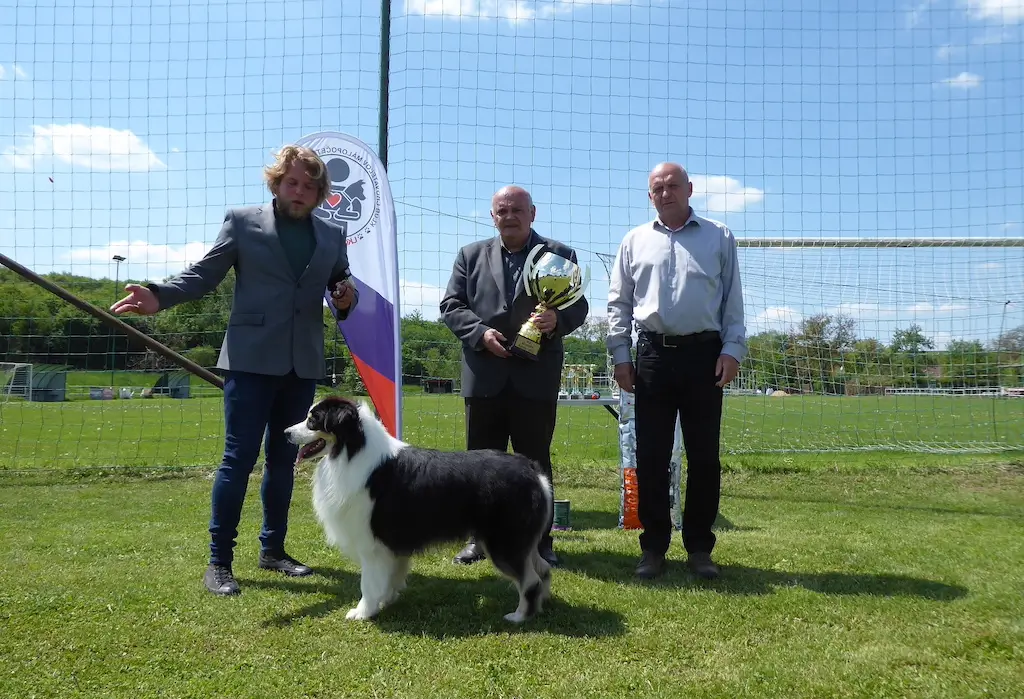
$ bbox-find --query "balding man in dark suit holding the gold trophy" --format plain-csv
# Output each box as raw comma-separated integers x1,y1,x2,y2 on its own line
440,186,590,565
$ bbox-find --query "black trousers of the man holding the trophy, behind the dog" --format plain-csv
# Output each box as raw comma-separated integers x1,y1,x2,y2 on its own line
466,388,558,548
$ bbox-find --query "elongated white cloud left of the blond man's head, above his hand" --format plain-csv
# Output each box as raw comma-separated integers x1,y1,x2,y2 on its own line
3,124,166,172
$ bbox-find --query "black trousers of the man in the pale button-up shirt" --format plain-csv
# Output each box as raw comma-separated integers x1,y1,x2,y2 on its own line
635,335,723,554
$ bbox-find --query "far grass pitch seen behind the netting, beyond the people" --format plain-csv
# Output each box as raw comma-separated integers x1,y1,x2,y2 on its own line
0,379,1024,470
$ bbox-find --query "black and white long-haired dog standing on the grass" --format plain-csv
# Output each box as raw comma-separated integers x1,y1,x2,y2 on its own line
286,396,551,623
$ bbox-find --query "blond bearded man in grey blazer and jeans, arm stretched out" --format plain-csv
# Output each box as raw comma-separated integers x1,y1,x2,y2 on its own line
111,145,358,595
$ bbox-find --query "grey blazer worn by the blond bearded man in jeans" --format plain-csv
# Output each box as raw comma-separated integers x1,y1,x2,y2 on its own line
147,203,358,380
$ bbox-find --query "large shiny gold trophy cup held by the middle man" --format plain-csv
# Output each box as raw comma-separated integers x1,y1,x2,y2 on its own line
508,245,590,361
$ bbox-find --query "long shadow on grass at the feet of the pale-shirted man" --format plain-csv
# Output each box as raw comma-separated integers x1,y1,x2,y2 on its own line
563,551,969,602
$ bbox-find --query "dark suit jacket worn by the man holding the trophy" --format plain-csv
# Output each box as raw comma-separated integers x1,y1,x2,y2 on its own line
440,233,590,400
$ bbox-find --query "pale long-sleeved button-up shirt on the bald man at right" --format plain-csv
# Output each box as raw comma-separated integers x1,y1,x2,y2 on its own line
607,208,746,364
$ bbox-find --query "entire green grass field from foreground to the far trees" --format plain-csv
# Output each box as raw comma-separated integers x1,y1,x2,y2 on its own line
0,372,1024,699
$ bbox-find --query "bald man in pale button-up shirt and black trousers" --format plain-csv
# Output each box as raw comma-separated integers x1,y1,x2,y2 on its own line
607,163,746,578
